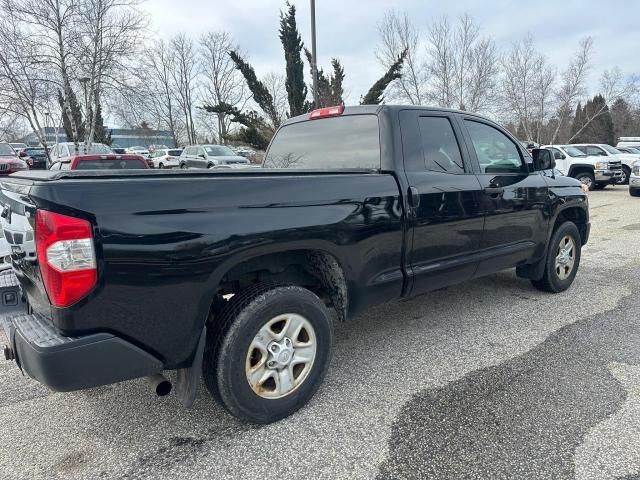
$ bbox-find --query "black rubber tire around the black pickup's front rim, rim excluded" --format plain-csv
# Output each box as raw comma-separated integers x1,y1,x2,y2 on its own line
531,222,582,293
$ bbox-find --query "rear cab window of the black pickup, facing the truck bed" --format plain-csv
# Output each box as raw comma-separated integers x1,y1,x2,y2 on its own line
263,114,380,170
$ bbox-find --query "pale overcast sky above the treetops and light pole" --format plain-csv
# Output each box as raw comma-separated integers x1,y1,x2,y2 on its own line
144,0,640,103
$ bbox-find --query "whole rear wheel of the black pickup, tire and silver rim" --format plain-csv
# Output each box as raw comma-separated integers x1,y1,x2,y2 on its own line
203,284,333,423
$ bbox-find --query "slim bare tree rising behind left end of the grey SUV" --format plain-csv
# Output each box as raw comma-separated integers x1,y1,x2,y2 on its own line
170,34,199,144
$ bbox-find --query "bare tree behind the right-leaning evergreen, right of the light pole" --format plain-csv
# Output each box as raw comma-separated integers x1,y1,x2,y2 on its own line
375,10,428,105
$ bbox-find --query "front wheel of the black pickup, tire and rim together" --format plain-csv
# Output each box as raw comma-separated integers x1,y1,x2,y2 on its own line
531,222,582,293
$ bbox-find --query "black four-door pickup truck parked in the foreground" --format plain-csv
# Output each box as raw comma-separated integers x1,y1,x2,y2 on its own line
0,106,590,423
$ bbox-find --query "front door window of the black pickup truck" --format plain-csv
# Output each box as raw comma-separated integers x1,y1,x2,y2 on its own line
464,120,526,173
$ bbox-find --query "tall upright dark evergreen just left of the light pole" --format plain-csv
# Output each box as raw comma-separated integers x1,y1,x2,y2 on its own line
280,2,311,117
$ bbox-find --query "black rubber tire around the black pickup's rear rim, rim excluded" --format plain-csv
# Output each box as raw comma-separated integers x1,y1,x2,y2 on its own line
202,284,333,423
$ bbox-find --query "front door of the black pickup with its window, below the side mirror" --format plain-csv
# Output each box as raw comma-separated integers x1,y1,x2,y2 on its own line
460,117,547,276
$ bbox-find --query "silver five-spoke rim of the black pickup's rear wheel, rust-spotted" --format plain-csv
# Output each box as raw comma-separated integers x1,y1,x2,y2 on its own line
245,313,317,399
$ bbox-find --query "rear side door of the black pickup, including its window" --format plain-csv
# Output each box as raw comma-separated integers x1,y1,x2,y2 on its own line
400,110,484,295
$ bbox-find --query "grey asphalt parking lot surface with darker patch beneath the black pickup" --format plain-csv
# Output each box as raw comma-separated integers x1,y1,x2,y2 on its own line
0,186,640,479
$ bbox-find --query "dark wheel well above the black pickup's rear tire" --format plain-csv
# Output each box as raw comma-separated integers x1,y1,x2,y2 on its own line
218,250,349,320
